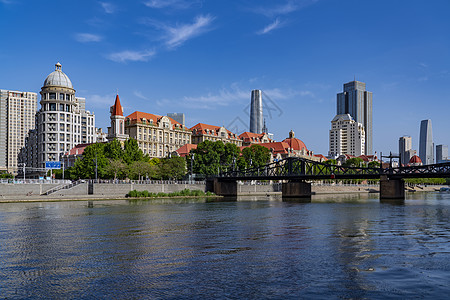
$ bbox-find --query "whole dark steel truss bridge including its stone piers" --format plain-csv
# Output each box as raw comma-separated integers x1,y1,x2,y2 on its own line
209,157,450,199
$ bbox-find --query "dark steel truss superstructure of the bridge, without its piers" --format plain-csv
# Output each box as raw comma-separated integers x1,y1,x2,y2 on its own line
217,157,450,181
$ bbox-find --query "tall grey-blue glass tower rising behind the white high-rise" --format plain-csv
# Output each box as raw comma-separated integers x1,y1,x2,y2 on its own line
336,81,373,155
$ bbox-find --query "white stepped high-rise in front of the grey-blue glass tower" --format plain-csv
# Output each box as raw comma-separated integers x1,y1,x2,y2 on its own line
328,114,366,158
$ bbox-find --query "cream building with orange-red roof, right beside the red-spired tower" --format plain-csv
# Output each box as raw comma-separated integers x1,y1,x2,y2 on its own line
125,111,192,158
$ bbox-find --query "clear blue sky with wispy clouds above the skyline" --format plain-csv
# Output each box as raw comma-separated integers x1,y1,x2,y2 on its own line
0,0,450,154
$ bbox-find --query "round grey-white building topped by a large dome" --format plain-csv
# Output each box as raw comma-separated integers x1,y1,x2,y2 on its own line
22,63,97,168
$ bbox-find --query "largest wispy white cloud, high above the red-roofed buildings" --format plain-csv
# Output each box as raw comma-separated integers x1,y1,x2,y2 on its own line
163,15,214,48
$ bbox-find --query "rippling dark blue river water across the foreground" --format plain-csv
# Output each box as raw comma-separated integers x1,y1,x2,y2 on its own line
0,193,450,299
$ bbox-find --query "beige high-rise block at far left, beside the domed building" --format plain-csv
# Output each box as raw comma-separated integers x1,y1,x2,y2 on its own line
0,90,37,174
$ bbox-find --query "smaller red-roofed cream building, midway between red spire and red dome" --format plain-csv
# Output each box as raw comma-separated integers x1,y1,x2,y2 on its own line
191,123,242,147
